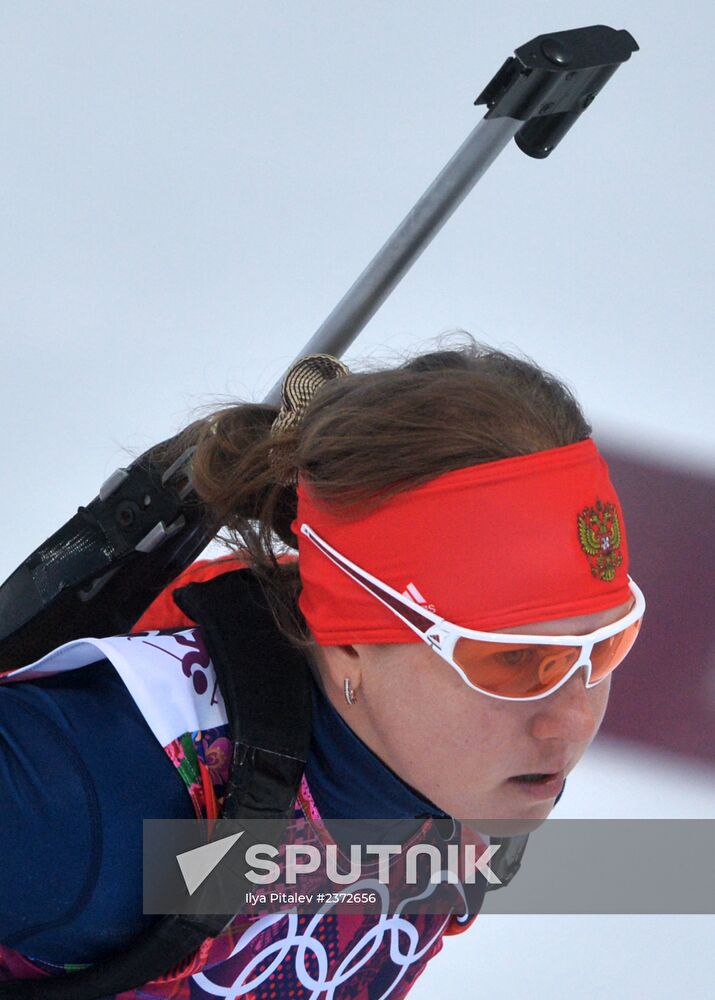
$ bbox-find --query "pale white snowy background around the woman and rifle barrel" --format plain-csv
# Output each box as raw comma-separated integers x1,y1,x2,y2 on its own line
0,0,715,1000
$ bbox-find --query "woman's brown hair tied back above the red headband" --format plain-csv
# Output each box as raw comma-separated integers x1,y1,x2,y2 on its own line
164,335,591,645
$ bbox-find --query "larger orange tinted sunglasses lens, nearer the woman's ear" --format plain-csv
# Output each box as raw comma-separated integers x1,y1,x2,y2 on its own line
453,638,580,698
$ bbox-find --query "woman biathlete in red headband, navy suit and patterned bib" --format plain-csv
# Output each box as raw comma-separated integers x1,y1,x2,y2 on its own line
0,340,644,1000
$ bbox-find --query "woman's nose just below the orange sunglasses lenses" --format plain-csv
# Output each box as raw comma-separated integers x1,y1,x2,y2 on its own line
529,670,609,743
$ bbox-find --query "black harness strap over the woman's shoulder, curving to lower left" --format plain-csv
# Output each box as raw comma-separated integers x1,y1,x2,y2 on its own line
0,570,311,1000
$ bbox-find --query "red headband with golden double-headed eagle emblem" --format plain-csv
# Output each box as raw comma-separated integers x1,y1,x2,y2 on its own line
292,438,630,646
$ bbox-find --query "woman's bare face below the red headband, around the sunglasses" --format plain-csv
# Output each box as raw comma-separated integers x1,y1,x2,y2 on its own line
316,603,630,832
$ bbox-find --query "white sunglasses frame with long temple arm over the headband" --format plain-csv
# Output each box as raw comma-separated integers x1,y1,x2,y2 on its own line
300,522,646,702
